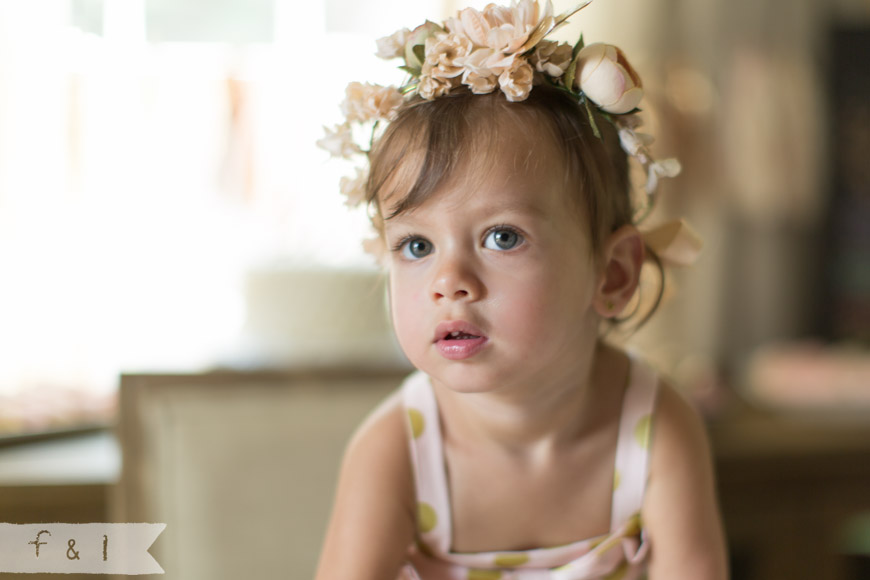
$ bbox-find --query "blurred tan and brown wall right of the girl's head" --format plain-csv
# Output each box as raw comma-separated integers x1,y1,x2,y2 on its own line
590,0,870,382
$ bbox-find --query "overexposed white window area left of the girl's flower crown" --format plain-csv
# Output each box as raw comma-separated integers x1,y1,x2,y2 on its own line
0,0,443,430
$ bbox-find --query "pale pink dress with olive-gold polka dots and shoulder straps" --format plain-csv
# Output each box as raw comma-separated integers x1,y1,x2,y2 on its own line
399,357,658,580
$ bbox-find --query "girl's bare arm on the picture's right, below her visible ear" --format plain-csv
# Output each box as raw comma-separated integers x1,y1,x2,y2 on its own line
643,385,728,580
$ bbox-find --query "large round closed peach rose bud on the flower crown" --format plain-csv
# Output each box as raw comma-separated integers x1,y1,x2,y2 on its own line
574,42,643,115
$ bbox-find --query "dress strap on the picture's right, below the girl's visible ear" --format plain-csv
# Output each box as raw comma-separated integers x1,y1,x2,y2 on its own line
610,354,658,531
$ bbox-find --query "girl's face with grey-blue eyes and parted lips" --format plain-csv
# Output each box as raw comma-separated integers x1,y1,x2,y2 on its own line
381,126,599,392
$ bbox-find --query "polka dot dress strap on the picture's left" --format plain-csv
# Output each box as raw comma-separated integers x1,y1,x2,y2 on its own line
402,371,452,554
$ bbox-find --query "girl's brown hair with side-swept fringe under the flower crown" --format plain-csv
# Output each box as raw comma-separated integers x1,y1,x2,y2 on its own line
366,85,663,326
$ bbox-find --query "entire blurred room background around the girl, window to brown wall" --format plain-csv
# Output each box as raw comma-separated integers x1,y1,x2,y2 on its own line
0,0,870,579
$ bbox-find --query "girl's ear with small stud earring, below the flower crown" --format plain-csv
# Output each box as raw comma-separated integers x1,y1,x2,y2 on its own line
594,225,644,318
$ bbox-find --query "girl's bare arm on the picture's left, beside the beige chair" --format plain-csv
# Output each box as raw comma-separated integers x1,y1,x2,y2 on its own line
316,393,414,580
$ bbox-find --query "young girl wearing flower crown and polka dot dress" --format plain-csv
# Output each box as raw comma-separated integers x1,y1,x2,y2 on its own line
317,0,726,580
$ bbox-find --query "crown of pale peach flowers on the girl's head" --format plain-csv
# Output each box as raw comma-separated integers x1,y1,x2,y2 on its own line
317,0,700,263
